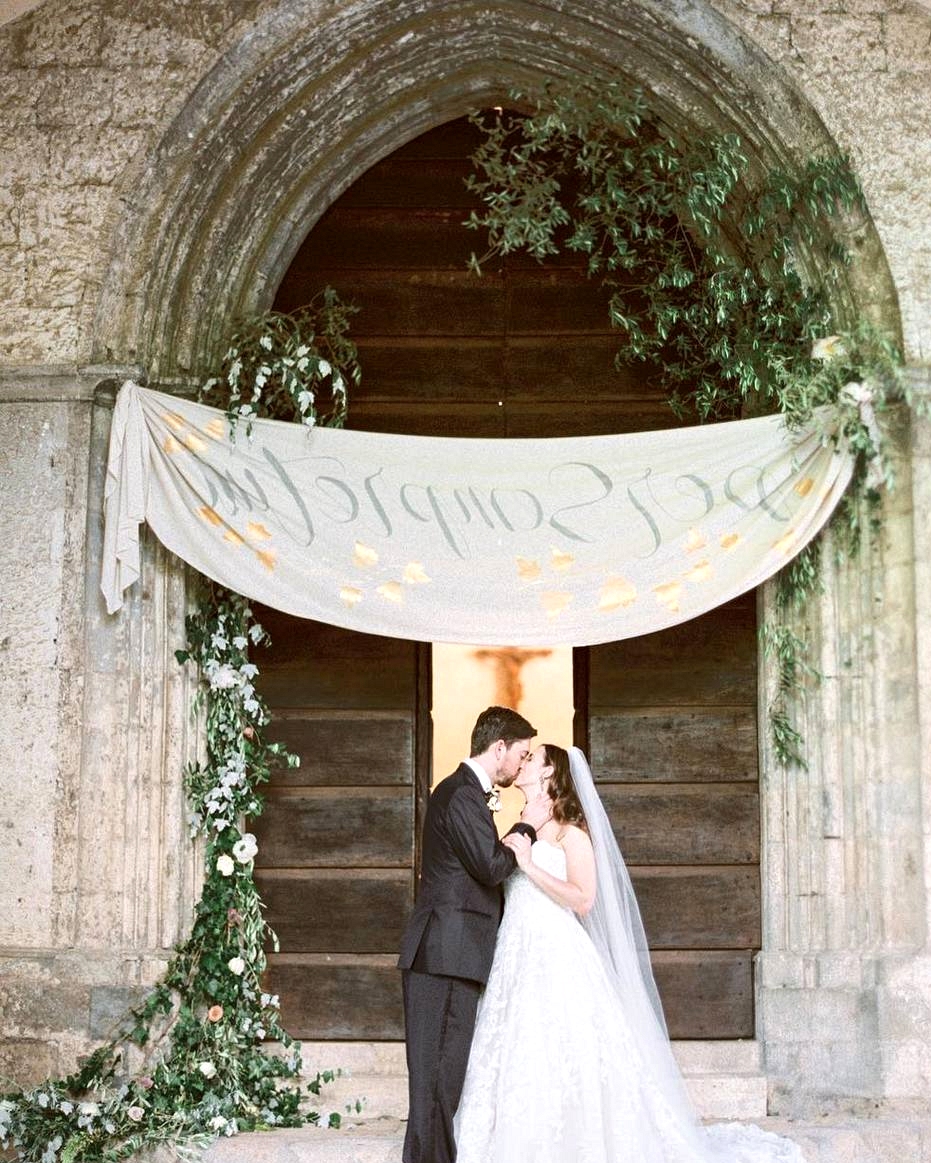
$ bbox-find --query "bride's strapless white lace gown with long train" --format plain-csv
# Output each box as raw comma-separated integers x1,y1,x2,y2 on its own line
456,840,803,1163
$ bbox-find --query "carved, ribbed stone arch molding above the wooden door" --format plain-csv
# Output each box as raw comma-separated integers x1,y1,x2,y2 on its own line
88,0,897,383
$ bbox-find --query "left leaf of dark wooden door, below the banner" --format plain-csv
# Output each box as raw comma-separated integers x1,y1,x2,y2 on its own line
252,609,420,1039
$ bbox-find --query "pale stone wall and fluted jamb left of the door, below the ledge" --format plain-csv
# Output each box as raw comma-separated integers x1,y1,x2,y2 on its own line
0,369,198,1082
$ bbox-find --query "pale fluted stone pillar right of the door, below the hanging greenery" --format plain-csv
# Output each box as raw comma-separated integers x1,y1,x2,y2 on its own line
757,374,931,1115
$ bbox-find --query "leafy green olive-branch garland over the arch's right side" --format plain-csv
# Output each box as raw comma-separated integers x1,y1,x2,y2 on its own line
466,81,908,766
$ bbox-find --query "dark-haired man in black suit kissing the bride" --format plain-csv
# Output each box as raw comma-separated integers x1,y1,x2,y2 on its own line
398,707,543,1163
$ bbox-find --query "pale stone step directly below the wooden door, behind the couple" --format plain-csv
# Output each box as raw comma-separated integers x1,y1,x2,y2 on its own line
294,1041,766,1119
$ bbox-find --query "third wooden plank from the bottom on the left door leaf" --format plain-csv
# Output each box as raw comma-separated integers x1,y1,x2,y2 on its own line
255,786,414,868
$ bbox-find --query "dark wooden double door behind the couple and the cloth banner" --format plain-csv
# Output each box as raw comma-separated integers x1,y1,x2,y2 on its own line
256,119,760,1039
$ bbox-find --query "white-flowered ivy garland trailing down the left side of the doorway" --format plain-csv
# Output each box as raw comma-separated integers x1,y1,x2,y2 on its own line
0,290,360,1163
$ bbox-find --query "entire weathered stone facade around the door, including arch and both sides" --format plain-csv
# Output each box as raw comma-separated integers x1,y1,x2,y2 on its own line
0,0,931,1110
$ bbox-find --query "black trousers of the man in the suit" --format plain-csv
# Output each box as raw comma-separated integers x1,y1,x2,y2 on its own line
401,969,482,1163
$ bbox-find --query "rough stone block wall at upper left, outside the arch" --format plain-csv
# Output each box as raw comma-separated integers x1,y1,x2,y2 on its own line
0,0,276,365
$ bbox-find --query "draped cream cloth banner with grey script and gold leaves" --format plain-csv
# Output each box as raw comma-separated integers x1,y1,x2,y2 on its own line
102,383,852,645
